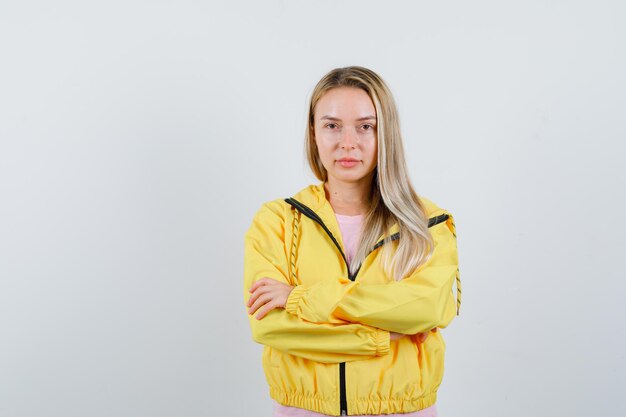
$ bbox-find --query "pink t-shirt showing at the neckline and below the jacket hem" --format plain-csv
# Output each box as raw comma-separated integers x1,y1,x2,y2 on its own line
272,213,437,417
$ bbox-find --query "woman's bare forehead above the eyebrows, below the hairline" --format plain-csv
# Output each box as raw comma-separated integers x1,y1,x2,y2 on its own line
315,87,376,120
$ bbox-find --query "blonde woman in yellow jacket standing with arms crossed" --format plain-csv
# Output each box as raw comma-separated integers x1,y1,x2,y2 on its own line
244,66,460,417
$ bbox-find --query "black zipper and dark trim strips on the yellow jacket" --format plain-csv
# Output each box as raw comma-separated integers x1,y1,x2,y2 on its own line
285,198,449,416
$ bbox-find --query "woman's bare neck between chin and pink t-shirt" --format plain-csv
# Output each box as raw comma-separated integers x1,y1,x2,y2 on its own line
324,177,372,216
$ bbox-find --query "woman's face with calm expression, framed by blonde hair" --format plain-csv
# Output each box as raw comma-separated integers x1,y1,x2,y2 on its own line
314,87,378,182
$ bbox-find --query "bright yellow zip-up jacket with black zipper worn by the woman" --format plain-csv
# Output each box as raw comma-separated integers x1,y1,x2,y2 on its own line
244,182,460,416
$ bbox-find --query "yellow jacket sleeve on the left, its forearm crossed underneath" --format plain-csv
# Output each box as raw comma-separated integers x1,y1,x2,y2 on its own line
244,200,389,363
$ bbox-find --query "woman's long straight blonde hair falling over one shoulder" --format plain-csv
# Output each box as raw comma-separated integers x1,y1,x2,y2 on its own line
305,66,433,281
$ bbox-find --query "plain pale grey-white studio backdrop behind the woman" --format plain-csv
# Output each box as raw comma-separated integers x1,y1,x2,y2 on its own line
0,0,626,417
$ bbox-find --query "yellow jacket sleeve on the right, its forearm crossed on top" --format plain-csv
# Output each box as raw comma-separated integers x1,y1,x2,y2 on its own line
285,213,460,334
